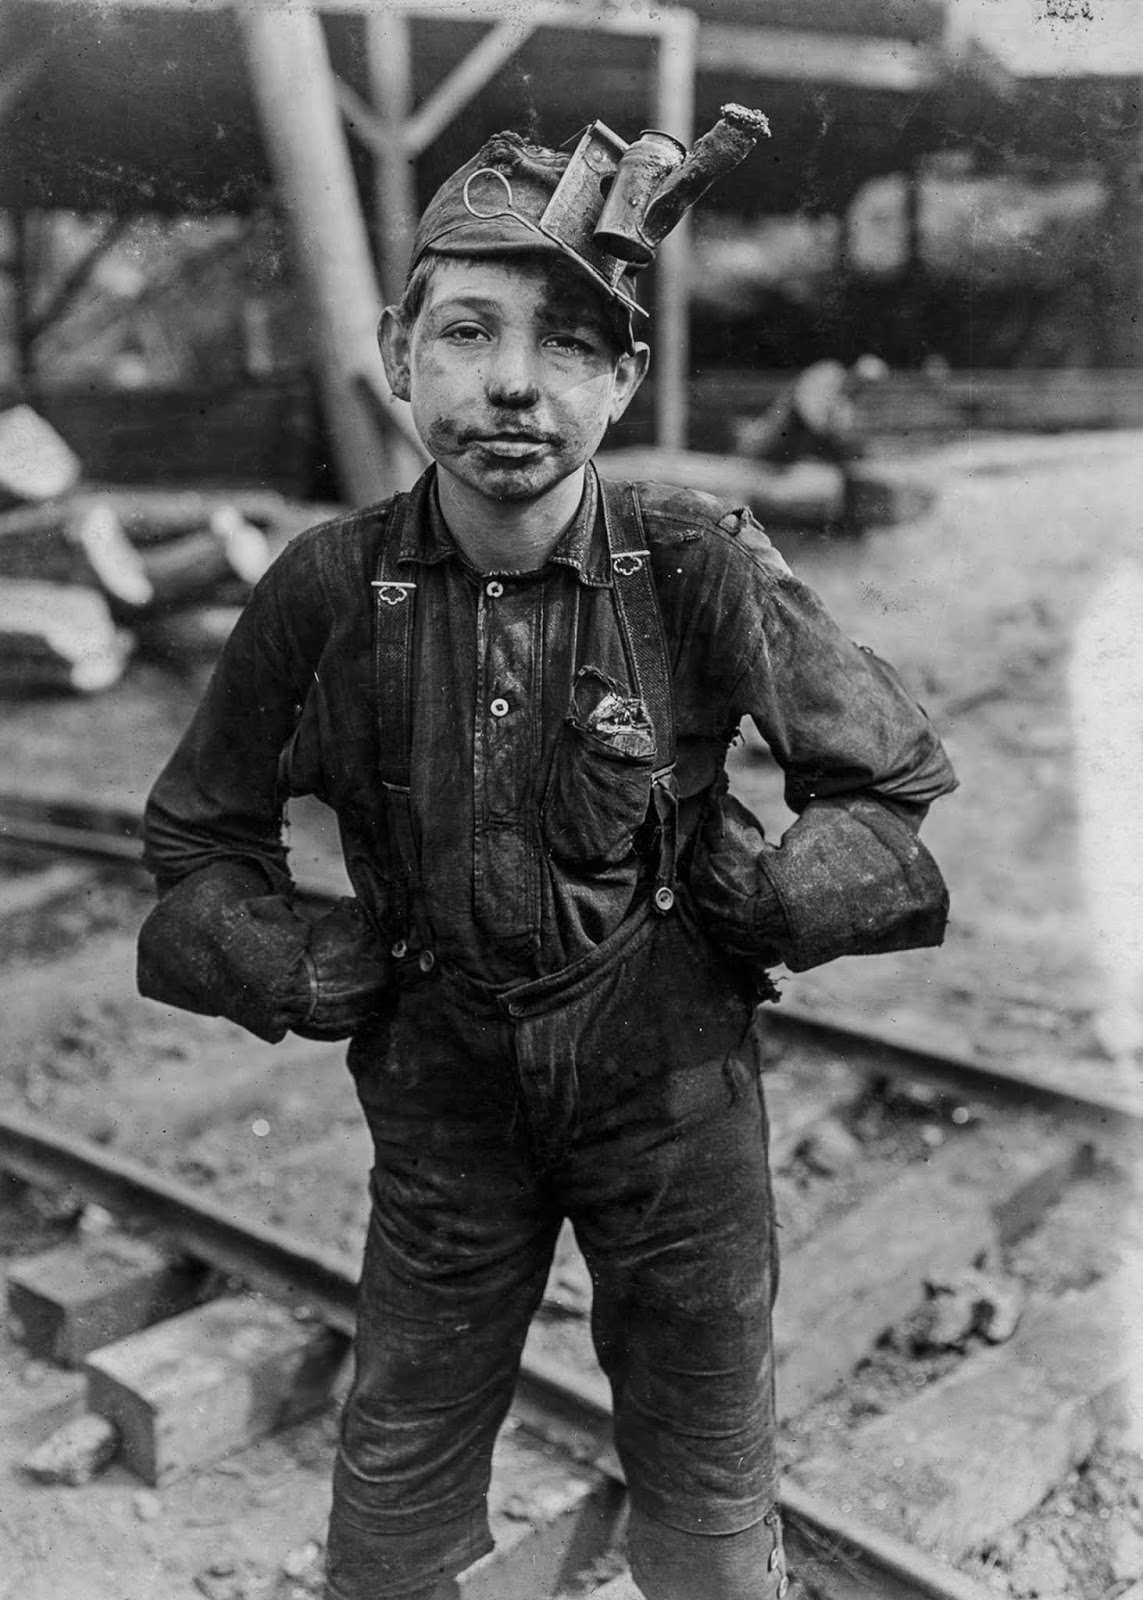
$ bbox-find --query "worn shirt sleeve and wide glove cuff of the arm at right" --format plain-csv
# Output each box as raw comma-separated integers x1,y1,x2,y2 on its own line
685,520,957,971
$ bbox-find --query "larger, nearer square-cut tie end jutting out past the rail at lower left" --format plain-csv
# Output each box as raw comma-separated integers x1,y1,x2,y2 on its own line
85,1296,347,1485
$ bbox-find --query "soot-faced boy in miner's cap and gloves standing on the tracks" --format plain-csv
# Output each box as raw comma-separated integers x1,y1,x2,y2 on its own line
139,114,953,1600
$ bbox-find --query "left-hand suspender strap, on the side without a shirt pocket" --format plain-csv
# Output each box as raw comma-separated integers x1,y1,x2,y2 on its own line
373,494,432,962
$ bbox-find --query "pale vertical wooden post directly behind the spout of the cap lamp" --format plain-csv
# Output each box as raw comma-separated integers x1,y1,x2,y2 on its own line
652,11,698,450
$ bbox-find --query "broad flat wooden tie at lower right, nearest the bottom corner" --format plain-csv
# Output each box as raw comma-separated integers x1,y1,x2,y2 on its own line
796,1264,1143,1560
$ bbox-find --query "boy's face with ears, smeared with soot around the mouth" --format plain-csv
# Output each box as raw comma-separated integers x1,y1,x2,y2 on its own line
381,256,647,502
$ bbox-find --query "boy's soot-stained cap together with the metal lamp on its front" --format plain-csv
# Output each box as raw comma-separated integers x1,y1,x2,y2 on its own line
410,106,770,347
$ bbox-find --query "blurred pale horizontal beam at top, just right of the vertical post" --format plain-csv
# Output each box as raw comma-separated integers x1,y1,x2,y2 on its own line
698,22,940,94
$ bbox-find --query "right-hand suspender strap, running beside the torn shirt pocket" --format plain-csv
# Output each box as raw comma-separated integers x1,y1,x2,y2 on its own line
599,478,679,914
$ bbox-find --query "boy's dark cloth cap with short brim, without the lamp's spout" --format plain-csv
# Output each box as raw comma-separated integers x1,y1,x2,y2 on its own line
410,132,647,350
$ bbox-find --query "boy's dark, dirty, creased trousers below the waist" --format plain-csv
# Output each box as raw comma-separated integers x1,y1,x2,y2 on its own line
328,902,776,1600
